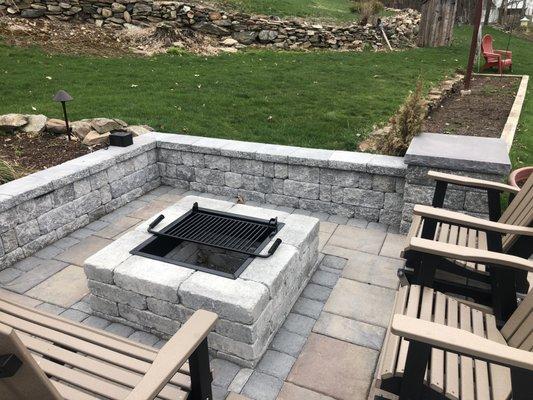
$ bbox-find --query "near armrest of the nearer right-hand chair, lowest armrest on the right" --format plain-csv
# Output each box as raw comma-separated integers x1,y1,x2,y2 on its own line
391,314,533,371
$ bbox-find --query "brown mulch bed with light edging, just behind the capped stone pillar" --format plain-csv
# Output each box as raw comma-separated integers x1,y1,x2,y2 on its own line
422,75,520,137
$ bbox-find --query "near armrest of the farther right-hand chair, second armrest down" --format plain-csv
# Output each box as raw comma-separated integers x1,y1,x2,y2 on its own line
413,204,533,236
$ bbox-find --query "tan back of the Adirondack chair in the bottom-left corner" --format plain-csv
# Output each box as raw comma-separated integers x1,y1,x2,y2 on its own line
0,323,63,400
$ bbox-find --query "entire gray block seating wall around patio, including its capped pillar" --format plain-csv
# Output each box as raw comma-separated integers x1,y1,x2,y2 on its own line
0,132,510,270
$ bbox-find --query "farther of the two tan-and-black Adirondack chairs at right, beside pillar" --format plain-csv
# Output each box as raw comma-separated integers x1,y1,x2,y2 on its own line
402,171,533,318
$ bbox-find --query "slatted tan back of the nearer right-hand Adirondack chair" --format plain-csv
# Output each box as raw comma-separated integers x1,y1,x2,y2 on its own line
501,291,533,351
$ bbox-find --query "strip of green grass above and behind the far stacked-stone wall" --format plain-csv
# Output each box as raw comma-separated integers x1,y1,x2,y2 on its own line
212,0,357,21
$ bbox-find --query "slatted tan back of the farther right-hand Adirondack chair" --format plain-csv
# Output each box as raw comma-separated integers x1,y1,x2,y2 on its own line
499,174,533,251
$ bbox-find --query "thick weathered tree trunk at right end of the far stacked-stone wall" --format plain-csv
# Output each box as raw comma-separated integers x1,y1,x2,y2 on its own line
418,0,457,47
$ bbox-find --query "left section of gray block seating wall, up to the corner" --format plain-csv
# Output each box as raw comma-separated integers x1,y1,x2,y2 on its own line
0,137,160,270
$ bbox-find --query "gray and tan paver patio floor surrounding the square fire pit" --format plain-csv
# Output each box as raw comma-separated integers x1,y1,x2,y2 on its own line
0,186,405,400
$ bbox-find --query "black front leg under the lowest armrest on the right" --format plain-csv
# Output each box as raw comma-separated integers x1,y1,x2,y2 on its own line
399,341,431,400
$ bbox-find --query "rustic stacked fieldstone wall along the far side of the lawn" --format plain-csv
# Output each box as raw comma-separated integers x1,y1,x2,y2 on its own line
4,0,420,50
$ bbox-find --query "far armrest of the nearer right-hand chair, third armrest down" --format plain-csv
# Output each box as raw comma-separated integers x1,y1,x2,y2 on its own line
406,237,533,272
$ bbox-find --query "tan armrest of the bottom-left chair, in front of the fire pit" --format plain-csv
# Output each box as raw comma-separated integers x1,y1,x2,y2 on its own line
126,310,218,400
